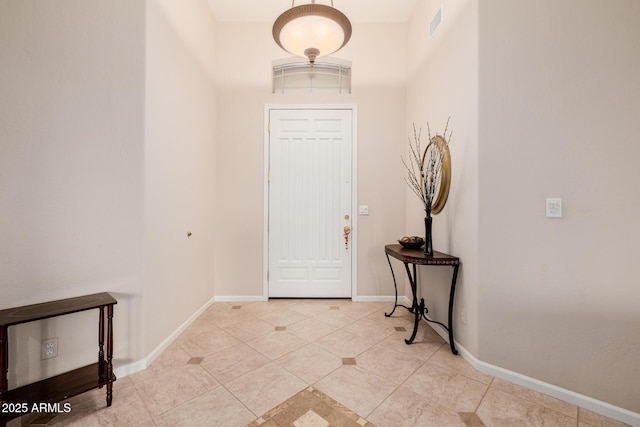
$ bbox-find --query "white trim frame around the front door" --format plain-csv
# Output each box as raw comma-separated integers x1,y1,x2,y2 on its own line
262,104,358,301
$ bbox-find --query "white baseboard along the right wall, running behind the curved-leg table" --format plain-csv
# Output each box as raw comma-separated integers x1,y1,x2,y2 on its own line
398,297,640,427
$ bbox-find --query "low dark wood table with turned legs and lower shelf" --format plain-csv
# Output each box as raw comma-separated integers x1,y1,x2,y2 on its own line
0,292,117,427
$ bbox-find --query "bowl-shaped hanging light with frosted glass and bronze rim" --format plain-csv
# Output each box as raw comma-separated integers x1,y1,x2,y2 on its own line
273,0,351,64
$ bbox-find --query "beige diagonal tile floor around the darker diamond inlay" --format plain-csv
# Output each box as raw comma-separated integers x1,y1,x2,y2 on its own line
9,300,625,427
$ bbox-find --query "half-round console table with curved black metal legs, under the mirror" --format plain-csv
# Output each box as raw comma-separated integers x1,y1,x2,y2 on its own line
384,244,460,354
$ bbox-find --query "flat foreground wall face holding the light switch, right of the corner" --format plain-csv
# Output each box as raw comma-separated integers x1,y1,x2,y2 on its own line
477,0,640,412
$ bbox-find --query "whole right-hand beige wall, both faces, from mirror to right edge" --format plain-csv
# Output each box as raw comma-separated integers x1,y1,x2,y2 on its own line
406,0,640,415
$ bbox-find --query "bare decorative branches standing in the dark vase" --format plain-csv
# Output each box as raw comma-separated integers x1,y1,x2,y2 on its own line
402,119,452,217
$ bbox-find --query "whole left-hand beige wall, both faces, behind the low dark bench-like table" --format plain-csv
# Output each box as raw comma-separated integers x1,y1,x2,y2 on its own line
0,0,216,387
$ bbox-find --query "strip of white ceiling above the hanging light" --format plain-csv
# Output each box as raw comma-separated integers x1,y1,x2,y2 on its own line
207,0,418,23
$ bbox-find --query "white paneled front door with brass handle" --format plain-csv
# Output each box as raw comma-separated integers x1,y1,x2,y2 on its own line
268,109,353,298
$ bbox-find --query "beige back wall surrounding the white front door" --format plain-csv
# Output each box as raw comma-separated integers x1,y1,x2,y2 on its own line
215,23,406,298
